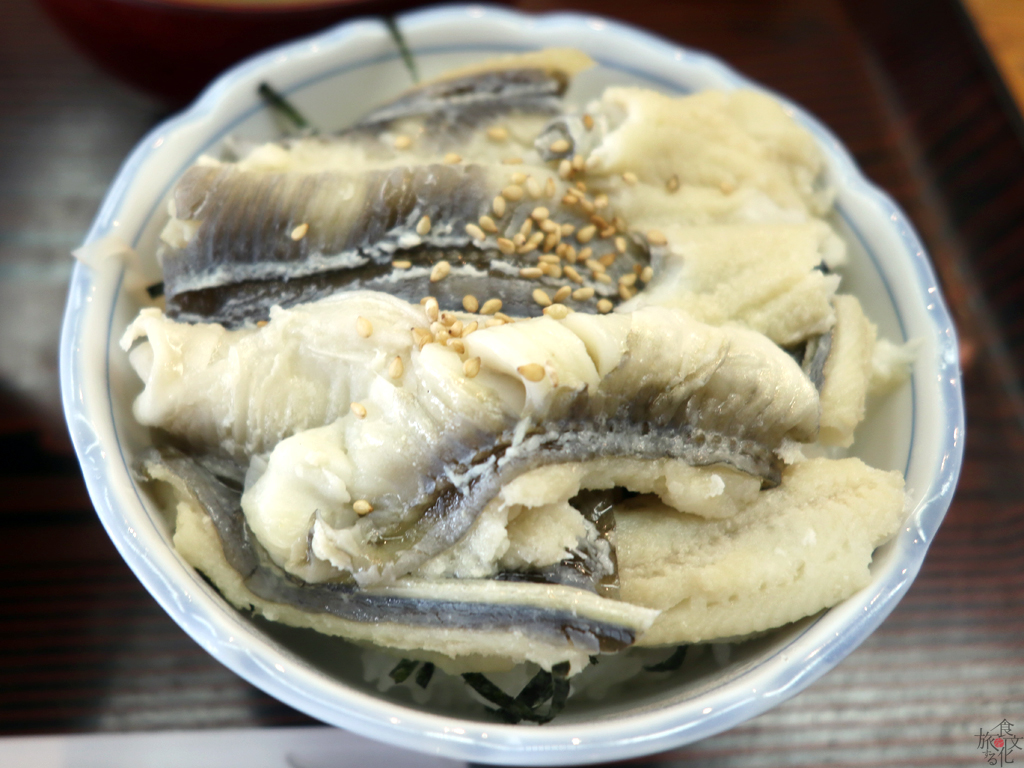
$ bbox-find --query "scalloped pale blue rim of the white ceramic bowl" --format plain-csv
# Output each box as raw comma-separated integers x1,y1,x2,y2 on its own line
60,6,964,765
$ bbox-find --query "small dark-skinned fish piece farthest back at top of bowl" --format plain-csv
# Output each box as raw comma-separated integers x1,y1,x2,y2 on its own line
346,69,568,140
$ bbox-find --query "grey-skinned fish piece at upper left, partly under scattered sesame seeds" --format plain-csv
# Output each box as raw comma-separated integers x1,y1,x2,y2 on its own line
163,164,650,327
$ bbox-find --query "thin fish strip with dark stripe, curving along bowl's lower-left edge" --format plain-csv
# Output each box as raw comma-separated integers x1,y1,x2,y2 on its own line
143,451,657,674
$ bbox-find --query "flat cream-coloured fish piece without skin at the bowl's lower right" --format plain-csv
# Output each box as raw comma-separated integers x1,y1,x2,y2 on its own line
615,459,904,645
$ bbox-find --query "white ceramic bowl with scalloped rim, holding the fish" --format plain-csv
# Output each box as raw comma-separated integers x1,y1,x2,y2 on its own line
60,6,964,765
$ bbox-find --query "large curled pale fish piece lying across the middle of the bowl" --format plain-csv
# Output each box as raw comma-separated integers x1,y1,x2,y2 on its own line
123,294,818,585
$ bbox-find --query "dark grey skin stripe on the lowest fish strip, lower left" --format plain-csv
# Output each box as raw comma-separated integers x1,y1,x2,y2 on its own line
139,449,636,653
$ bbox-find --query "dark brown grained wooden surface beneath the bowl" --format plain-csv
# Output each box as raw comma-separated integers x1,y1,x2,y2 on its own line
0,0,1024,766
